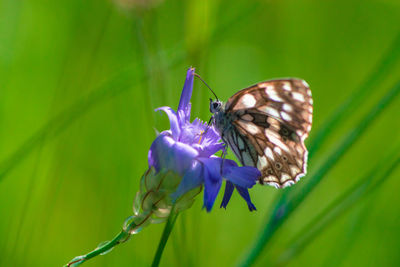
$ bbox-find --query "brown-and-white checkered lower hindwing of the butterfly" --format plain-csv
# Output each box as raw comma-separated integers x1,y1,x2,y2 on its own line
229,115,307,188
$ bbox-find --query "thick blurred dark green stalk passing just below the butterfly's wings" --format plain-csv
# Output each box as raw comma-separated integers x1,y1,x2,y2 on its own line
239,82,400,266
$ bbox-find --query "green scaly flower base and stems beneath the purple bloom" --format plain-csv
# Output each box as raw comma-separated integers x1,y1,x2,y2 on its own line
66,167,192,266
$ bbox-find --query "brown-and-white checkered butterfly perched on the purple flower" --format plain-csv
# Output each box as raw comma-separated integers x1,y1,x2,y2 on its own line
210,78,313,188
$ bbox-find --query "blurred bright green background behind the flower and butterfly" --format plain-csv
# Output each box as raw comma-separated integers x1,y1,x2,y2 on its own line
0,0,400,266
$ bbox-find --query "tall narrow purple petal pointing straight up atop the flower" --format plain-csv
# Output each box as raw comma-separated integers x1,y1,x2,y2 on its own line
177,68,194,123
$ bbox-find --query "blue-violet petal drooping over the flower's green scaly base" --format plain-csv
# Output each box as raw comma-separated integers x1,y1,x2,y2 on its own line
171,161,204,201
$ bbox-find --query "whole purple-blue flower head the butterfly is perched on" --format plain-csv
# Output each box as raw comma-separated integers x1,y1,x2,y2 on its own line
148,68,260,211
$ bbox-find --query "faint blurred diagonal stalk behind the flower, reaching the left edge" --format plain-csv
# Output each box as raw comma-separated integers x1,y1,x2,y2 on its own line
0,6,257,185
